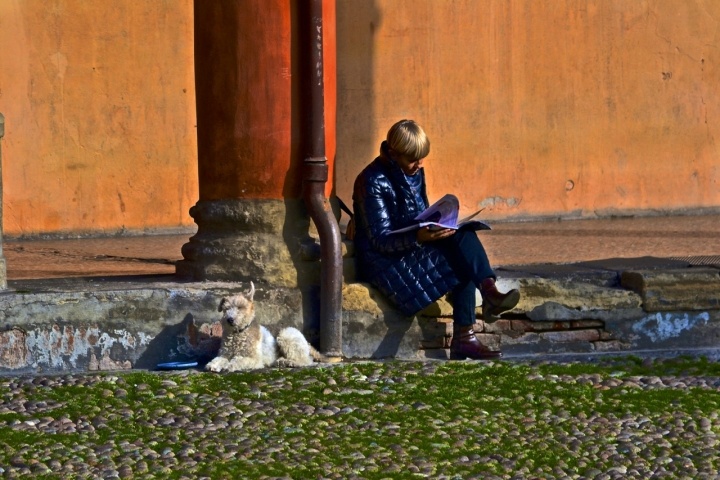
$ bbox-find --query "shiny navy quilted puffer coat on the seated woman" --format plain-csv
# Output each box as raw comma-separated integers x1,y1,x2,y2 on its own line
353,142,460,316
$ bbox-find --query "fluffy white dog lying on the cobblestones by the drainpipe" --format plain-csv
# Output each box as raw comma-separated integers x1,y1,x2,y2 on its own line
205,282,324,372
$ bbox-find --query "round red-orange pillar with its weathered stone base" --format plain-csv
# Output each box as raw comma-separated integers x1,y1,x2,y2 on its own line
176,0,335,287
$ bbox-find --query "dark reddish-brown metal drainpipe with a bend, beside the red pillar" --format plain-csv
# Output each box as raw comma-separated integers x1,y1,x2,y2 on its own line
303,0,342,358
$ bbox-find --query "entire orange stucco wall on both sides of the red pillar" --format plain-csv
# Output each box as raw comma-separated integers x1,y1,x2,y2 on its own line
0,0,720,236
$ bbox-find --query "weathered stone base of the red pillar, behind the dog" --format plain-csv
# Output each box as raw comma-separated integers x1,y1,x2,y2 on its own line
176,199,319,288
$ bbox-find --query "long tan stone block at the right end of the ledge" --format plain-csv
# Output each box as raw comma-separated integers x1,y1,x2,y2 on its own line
621,268,720,312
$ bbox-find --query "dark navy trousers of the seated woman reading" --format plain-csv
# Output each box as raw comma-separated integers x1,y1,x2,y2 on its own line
437,230,495,326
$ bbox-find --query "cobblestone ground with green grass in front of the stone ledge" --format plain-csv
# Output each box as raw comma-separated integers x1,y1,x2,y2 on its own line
0,358,720,479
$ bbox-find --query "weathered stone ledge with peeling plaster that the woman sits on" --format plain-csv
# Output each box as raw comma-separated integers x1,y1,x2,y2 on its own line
0,262,720,373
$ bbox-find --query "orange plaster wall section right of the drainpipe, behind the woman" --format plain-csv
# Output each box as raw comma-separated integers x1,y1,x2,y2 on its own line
336,0,720,218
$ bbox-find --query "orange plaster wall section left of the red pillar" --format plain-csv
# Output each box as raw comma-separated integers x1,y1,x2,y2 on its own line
0,0,198,236
